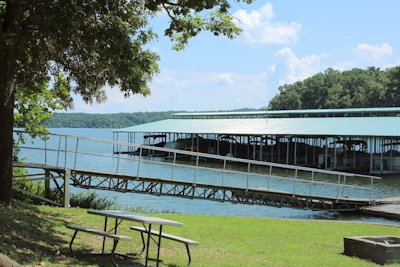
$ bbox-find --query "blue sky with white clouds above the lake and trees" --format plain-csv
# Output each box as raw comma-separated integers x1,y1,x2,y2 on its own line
69,0,400,113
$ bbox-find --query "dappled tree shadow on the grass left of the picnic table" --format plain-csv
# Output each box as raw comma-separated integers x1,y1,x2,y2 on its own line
0,201,143,266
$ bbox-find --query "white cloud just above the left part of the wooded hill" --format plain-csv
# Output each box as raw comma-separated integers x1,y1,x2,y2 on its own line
274,47,327,85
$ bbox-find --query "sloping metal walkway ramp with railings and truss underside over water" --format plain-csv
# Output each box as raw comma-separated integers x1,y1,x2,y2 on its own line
14,132,380,211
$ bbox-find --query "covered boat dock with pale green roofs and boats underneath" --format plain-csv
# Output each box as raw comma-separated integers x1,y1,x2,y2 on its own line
113,107,400,174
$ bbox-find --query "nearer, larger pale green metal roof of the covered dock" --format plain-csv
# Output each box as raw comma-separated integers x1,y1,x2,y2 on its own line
114,117,400,138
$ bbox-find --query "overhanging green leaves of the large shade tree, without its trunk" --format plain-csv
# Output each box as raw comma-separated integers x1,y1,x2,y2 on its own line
0,0,252,137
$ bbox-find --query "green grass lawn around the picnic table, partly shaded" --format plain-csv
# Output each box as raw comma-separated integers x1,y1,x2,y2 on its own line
0,202,400,266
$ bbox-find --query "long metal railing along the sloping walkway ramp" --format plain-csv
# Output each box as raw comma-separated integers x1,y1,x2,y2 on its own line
15,131,380,200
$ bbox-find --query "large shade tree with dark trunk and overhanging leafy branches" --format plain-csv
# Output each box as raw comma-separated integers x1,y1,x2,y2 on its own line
0,0,252,204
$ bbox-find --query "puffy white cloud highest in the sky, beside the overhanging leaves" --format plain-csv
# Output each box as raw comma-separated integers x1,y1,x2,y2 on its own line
233,3,301,44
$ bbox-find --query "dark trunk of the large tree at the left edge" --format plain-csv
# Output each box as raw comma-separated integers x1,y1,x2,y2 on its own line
0,0,21,205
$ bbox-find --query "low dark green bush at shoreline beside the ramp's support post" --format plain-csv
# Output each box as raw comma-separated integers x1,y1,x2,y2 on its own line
70,191,115,210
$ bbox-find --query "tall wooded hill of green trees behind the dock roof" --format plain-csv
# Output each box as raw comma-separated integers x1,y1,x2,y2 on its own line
268,67,400,110
